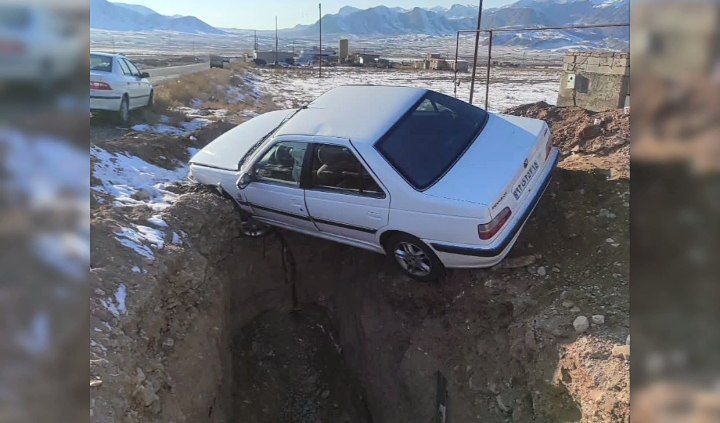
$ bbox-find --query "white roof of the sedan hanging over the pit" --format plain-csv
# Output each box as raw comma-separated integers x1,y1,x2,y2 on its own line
275,85,427,143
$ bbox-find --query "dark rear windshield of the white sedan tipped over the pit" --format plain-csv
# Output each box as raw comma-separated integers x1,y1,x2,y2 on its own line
376,91,488,190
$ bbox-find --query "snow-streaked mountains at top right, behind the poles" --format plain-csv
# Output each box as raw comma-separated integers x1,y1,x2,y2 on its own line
283,0,630,48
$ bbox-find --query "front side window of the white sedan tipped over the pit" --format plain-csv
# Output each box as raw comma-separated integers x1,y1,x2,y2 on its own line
252,142,308,186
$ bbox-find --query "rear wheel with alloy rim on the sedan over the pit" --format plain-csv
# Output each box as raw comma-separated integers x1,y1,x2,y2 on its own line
385,233,445,282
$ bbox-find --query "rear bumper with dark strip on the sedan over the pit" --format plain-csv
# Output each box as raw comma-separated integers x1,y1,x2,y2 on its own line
423,149,560,268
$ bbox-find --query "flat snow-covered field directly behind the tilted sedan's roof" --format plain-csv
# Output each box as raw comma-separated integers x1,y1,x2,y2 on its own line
256,67,560,112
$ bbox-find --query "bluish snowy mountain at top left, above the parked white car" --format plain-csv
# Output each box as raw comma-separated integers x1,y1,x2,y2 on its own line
90,0,225,34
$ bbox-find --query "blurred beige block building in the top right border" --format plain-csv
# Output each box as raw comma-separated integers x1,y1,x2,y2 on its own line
631,1,720,79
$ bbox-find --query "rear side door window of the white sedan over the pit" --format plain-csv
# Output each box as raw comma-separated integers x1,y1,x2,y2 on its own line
310,144,385,197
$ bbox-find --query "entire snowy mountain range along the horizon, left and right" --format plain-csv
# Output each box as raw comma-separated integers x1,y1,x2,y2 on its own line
90,0,630,49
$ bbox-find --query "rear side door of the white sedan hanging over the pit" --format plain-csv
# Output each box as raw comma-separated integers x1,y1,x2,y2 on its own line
305,139,390,246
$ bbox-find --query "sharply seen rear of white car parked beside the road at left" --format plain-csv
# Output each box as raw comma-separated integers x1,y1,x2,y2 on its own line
90,53,154,123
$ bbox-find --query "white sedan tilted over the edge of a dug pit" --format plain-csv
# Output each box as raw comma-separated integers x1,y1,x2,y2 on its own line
190,86,558,281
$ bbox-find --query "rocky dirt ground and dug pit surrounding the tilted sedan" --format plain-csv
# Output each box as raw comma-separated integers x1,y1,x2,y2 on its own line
90,64,629,422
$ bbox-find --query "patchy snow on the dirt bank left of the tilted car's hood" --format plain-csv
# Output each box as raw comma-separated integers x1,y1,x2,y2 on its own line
90,146,196,211
